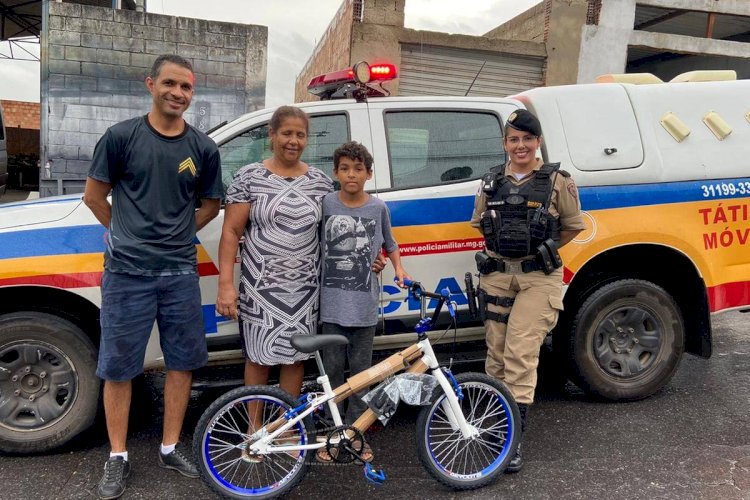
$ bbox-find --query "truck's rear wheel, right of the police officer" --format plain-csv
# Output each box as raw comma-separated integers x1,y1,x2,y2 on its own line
571,279,685,401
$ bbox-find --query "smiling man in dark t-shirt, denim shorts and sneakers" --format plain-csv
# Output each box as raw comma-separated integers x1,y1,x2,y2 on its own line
84,55,222,499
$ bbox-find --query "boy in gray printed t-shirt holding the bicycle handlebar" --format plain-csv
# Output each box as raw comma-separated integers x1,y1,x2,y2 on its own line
318,141,409,461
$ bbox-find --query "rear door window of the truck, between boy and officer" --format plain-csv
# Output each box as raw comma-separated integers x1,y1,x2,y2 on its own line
386,111,505,189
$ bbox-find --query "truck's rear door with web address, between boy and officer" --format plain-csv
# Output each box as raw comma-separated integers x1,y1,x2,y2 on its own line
370,99,517,328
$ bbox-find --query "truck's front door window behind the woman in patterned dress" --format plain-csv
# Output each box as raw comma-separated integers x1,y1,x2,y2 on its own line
214,114,349,190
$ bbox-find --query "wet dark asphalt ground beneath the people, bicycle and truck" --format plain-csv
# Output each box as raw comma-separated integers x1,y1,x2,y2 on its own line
0,312,750,500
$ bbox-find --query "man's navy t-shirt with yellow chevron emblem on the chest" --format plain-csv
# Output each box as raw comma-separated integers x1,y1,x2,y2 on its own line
89,116,222,276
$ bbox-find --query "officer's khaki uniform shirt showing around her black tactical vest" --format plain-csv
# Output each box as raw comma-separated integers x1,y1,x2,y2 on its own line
471,158,586,258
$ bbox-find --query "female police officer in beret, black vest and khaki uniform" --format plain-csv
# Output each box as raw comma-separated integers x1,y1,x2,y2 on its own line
471,110,585,472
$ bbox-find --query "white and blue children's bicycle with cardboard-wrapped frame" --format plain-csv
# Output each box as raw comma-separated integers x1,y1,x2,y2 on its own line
193,280,520,499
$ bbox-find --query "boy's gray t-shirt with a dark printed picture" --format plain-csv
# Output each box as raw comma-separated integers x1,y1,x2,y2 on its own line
320,192,398,327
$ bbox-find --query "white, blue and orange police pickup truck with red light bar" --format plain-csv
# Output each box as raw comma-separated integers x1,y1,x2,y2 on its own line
0,65,750,452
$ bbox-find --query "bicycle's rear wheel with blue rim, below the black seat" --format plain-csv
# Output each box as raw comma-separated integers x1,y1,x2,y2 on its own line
193,386,314,499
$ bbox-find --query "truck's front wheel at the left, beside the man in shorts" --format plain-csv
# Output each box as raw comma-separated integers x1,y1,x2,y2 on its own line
0,311,99,453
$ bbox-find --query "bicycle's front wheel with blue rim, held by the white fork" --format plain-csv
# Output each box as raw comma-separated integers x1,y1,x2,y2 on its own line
417,373,521,490
